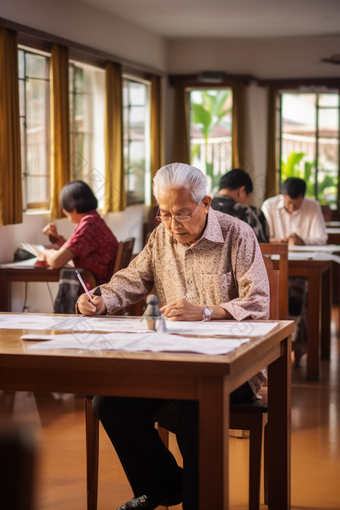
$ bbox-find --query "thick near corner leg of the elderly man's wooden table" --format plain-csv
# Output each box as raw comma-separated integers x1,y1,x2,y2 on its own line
199,377,230,510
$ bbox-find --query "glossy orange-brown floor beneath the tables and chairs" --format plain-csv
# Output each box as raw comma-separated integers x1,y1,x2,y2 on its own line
0,312,340,510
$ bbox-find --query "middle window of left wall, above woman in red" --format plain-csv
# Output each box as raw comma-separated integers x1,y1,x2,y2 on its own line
69,61,105,209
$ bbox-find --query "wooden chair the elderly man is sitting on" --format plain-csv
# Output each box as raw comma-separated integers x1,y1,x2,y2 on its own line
85,257,279,510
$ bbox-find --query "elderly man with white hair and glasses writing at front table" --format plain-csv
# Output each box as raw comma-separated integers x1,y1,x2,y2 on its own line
77,163,269,510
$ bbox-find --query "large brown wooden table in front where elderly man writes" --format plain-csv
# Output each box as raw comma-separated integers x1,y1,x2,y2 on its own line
0,318,294,510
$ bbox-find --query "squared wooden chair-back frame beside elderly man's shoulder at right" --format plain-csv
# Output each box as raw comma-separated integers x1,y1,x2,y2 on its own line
260,243,288,320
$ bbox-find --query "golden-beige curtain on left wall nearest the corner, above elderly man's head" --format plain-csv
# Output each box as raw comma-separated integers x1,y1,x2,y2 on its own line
150,75,164,205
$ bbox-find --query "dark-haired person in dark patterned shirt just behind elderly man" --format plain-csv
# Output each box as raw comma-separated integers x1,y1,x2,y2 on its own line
211,168,269,243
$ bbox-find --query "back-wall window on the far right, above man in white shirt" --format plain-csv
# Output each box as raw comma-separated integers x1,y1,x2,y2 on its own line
280,93,340,209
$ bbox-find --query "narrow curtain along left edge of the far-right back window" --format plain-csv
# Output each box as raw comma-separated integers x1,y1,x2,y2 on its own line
265,87,280,198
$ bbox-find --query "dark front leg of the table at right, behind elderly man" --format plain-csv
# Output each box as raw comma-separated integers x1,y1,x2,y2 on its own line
307,268,321,381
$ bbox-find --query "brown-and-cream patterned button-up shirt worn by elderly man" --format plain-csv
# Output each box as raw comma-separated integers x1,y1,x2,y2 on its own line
100,209,269,394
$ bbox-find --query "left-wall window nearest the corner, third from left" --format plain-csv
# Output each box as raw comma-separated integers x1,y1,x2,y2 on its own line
123,77,151,205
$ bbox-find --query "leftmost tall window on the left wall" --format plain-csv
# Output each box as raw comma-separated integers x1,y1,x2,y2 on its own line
18,47,50,210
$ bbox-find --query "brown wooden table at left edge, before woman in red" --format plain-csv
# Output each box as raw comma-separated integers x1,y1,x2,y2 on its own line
0,266,59,312
